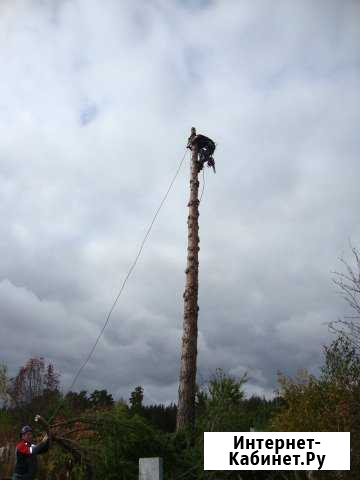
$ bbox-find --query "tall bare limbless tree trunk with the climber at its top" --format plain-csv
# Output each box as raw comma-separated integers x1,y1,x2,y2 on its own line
176,132,200,431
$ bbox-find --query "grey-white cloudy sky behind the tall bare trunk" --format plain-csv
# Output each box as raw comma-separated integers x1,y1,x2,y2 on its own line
0,0,360,402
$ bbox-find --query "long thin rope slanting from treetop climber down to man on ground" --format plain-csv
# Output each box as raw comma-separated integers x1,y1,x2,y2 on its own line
49,150,186,423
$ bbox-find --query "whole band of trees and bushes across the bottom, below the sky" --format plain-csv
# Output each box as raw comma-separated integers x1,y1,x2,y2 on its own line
0,248,360,480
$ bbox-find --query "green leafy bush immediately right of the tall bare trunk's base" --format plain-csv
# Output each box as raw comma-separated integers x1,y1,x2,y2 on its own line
169,369,290,480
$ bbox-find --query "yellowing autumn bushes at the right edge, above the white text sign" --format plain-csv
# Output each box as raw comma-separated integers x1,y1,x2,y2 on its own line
272,336,360,479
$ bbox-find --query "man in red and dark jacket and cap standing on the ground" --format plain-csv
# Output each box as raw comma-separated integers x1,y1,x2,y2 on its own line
12,425,50,480
